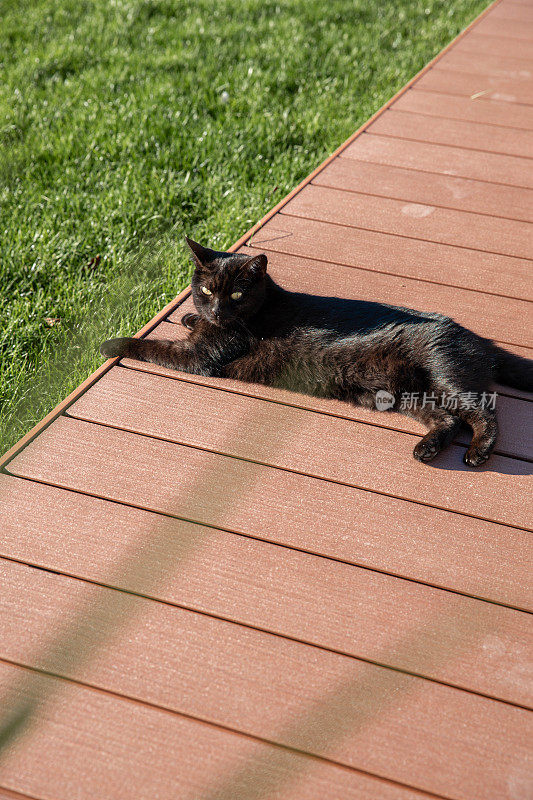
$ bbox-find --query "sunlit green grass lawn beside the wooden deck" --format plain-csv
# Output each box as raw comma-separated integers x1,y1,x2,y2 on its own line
0,0,486,451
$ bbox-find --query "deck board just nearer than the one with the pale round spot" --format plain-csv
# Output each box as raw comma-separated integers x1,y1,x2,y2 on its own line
250,211,533,303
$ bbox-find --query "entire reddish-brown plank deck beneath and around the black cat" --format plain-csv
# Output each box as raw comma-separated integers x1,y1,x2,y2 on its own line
0,0,533,800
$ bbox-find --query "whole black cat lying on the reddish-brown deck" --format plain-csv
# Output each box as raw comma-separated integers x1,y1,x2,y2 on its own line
101,239,533,467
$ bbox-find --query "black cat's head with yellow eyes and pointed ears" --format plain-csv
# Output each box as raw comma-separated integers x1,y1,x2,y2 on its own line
187,239,267,325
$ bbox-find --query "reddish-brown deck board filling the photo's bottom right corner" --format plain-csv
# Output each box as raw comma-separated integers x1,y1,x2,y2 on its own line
2,564,533,796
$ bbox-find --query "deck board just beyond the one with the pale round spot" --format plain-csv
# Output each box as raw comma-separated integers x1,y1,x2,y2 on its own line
311,156,533,222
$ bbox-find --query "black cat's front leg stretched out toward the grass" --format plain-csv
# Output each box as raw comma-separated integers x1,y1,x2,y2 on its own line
100,337,216,375
